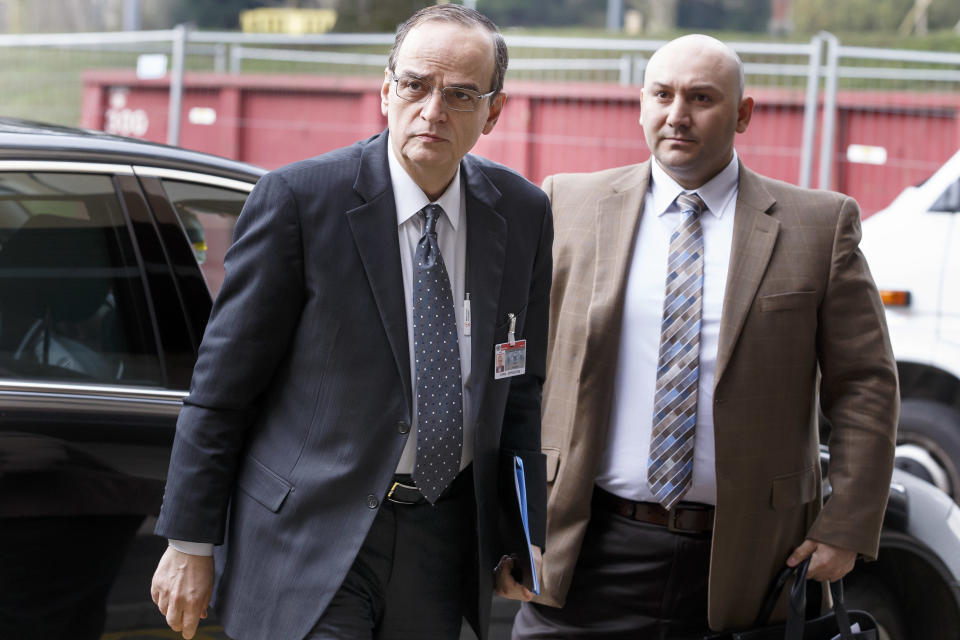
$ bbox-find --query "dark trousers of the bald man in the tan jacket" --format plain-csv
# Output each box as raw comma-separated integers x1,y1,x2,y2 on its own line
513,505,710,640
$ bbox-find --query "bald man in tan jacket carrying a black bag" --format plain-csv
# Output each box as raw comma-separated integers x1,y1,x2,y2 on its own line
514,36,899,640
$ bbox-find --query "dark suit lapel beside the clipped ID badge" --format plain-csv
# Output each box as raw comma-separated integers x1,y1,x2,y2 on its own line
461,156,506,424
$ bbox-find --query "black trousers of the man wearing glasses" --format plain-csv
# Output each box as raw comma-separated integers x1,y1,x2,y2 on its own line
307,468,477,640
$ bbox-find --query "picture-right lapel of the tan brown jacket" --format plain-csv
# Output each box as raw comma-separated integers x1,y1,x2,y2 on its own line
714,163,780,388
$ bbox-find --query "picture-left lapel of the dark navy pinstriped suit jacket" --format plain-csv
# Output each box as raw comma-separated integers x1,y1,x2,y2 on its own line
346,133,413,415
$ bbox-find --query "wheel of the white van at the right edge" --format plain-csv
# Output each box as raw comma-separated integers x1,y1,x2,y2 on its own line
896,399,960,500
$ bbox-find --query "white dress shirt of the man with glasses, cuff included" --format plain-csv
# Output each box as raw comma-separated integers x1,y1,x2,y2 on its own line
169,140,474,556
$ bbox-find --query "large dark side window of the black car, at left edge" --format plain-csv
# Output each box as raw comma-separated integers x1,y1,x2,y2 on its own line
0,172,162,385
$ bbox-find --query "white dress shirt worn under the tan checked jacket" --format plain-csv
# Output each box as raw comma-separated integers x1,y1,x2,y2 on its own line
596,153,739,504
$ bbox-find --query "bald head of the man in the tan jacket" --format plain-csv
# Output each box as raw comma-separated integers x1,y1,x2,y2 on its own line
640,35,753,189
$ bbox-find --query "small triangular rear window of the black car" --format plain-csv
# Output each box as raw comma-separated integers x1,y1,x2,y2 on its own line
163,180,248,297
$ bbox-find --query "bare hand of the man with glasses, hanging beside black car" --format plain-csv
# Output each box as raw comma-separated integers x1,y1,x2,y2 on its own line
150,547,213,640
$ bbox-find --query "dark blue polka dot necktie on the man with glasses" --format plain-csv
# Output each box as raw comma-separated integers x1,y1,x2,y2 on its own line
413,204,463,504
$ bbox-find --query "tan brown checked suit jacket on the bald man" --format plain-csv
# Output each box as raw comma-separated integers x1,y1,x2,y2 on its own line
538,161,899,630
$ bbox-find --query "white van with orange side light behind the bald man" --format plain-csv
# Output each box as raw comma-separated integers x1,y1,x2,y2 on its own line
860,151,960,501
